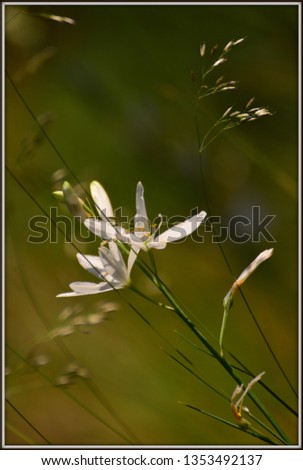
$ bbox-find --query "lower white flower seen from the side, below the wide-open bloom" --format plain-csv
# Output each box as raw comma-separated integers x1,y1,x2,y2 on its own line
57,242,136,297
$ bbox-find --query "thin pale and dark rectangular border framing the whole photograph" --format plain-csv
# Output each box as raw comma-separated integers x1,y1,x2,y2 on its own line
1,1,302,451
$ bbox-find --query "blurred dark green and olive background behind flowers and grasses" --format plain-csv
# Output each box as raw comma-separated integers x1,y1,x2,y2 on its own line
5,4,298,445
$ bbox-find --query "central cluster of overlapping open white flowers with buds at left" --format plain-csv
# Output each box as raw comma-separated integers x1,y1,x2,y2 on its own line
57,181,206,297
